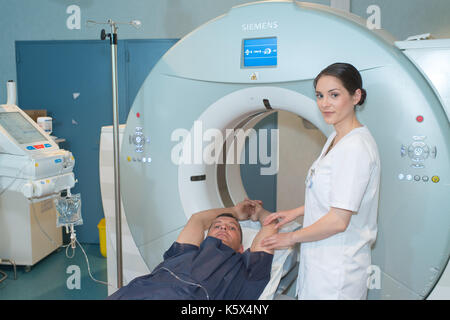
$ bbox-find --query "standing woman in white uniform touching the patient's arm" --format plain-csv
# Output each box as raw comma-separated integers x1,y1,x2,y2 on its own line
262,63,380,299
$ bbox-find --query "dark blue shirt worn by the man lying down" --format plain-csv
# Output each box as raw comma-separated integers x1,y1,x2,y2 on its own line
108,237,273,300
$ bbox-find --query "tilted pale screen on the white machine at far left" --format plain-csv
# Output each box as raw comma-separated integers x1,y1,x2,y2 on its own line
0,112,47,144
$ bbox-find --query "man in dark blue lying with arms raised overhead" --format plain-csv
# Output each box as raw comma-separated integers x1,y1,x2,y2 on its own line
108,199,277,300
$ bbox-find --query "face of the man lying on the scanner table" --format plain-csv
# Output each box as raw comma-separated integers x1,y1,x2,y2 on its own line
208,217,244,253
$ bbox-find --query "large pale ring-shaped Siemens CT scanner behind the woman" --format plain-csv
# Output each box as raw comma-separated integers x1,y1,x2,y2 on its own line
120,1,450,299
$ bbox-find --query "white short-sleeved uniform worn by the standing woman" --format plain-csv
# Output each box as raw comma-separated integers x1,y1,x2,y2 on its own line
297,126,380,299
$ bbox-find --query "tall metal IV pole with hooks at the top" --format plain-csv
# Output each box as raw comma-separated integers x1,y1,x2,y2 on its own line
87,19,141,289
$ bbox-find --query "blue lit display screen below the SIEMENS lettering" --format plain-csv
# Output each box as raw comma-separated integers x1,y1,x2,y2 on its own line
242,37,278,68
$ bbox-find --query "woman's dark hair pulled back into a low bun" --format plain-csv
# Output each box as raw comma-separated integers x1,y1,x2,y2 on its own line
314,62,367,106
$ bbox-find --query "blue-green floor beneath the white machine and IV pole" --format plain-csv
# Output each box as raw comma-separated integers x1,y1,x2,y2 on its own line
0,244,108,300
